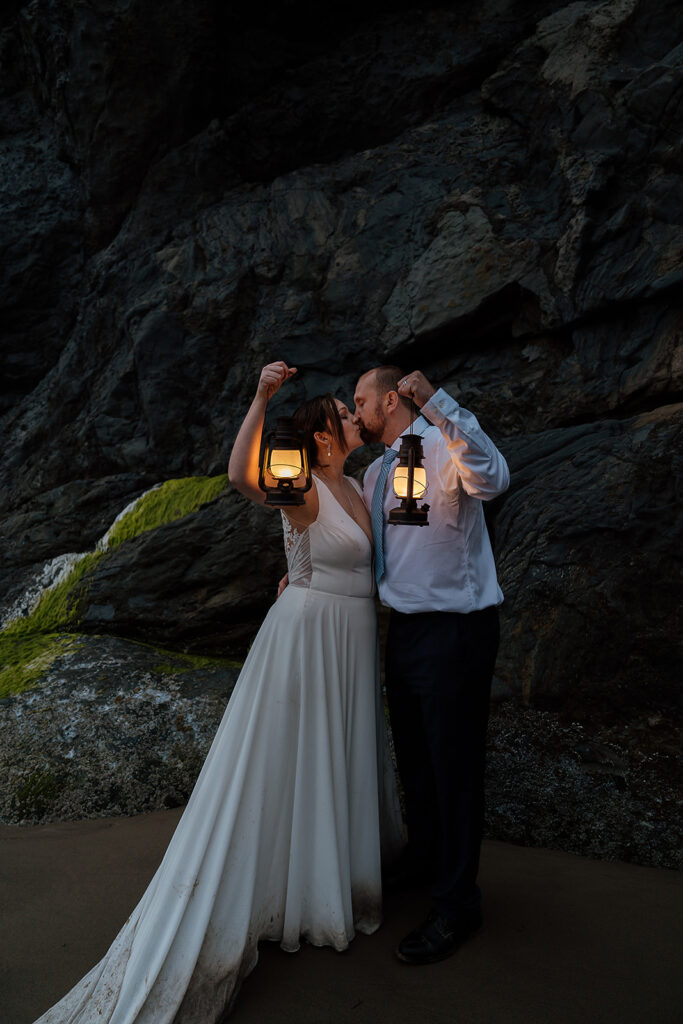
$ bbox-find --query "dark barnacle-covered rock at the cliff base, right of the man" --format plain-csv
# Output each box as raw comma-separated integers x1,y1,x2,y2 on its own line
486,705,681,869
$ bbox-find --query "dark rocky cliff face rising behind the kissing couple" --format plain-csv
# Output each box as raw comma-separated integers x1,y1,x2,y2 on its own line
0,0,683,843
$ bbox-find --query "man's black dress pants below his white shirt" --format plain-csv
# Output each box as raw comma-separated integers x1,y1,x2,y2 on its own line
386,607,499,920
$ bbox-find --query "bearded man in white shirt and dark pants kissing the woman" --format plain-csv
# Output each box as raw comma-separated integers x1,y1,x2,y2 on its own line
354,367,510,964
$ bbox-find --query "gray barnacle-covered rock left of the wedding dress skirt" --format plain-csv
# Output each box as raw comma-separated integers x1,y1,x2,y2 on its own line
0,637,239,823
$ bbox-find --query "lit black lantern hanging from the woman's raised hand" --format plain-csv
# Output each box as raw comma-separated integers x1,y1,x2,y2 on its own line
258,416,311,508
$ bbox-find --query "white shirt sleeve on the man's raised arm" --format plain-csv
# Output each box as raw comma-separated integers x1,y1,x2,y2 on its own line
421,388,510,501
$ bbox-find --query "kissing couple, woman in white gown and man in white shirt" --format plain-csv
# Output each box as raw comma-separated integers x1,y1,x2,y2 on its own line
34,360,509,1024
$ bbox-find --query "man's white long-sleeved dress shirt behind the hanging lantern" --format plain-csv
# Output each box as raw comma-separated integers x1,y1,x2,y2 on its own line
362,388,510,612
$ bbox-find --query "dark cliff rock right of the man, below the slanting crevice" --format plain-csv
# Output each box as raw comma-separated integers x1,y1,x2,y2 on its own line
496,404,683,714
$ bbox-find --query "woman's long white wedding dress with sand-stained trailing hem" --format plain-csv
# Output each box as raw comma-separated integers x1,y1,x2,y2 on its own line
40,480,402,1024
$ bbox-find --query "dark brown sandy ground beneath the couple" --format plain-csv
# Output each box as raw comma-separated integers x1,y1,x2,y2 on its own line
0,811,683,1024
